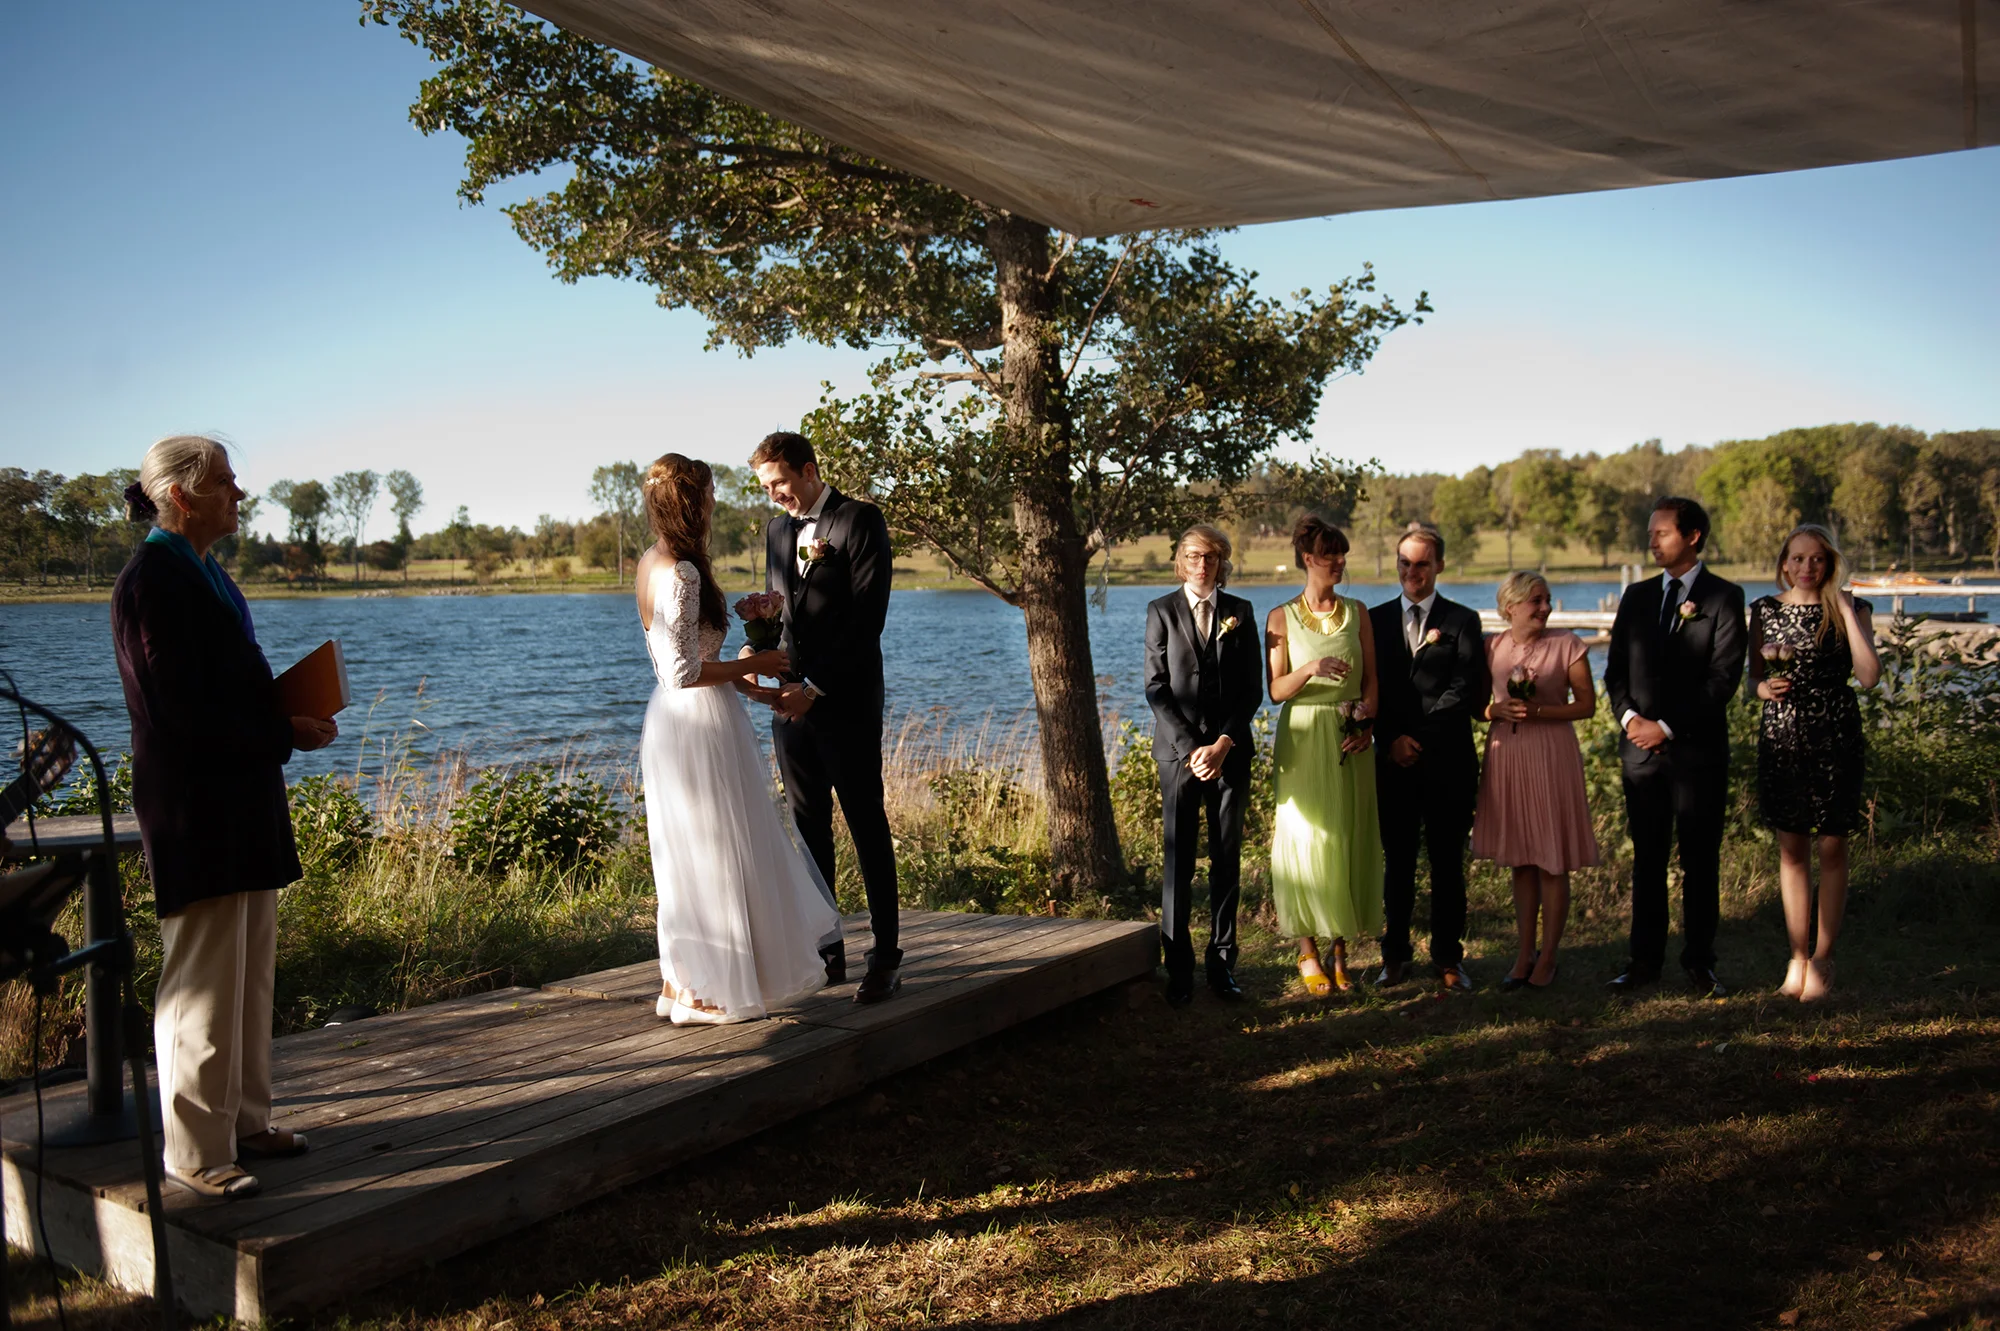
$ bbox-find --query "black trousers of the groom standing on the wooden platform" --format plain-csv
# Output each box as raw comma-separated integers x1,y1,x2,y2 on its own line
770,697,902,965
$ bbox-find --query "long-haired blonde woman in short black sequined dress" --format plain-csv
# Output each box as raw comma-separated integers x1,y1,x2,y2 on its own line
1750,522,1882,1003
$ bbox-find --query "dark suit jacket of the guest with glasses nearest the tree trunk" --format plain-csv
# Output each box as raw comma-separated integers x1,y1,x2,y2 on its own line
1146,588,1264,763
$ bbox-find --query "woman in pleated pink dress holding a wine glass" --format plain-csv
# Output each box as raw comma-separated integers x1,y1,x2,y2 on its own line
1472,574,1598,989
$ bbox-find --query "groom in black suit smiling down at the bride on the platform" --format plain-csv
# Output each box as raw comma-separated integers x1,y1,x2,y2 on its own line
750,432,902,1003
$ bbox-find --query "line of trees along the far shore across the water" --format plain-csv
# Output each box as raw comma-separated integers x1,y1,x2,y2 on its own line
0,424,2000,586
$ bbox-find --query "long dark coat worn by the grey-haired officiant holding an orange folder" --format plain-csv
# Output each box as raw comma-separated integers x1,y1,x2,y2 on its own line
112,544,302,915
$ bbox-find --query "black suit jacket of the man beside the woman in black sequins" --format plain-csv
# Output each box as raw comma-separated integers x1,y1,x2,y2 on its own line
1604,566,1750,765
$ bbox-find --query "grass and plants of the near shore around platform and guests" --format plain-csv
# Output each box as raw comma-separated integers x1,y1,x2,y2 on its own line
0,627,2000,1331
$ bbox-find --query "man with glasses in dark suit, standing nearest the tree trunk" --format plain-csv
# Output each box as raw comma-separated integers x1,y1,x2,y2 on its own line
1146,524,1264,1007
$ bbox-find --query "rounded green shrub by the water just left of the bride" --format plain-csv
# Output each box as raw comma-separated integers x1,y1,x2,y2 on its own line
452,765,624,875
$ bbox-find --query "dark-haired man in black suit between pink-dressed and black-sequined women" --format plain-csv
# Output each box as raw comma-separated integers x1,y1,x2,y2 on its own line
1604,496,1748,997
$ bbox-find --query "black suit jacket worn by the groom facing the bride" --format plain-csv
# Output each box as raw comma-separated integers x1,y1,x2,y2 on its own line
764,486,894,719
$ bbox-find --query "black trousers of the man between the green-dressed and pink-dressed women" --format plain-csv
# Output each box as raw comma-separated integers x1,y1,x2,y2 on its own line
1376,755,1478,967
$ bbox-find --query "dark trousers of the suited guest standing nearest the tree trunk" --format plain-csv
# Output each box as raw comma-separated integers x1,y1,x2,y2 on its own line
1160,743,1250,975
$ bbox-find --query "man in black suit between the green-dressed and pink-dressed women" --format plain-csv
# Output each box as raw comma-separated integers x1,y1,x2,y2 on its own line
1368,524,1492,993
